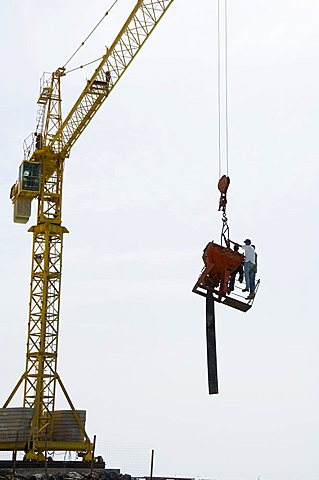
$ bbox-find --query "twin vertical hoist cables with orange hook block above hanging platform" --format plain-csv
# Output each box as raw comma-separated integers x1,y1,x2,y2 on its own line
217,0,230,246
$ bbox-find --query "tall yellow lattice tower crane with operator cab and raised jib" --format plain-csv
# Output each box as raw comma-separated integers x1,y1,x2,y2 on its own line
0,0,174,461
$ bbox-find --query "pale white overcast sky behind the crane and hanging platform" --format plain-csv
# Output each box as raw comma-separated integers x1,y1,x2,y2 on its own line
0,0,319,480
